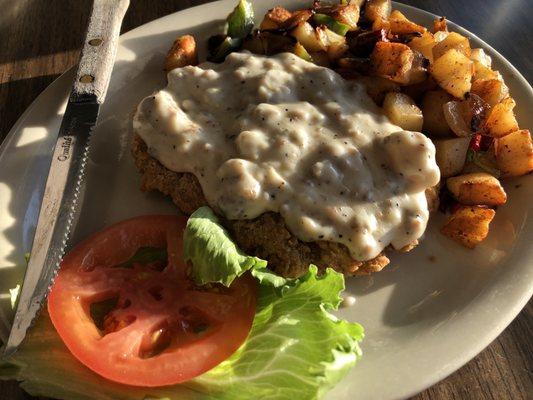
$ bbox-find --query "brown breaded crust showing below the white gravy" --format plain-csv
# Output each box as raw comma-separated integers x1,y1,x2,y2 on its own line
132,135,392,277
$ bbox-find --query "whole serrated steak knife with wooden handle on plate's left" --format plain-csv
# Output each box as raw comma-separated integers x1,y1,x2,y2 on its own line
4,0,129,356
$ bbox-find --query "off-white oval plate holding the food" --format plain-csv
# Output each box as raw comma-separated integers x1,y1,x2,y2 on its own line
0,0,533,400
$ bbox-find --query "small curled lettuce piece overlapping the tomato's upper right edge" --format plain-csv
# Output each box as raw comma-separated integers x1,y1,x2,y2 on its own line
183,207,267,287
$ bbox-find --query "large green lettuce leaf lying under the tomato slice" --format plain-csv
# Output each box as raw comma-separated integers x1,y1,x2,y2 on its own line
0,209,364,400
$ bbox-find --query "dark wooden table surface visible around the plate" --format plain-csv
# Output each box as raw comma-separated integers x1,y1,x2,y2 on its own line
0,0,533,400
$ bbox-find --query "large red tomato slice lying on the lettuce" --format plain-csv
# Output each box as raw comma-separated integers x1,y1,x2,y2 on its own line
48,216,256,387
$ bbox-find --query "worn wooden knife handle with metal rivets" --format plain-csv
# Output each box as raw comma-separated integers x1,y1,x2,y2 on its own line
70,0,129,104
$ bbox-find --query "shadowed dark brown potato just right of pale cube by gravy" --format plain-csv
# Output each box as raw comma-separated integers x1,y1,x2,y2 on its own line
422,89,453,136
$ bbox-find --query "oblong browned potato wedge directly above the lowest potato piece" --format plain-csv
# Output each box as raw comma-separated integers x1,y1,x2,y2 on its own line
446,172,507,206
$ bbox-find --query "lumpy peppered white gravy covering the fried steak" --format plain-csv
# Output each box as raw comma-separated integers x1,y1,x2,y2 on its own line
133,53,439,261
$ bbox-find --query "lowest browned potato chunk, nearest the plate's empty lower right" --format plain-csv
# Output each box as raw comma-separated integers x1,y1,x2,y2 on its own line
440,206,496,249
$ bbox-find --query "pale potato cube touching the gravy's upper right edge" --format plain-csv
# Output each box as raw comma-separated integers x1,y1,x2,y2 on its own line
383,92,424,132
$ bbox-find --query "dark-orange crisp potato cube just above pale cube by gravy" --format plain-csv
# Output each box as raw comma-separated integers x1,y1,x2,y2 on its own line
370,42,414,85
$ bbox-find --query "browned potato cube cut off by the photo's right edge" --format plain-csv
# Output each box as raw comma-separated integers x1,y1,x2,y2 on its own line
495,129,533,177
